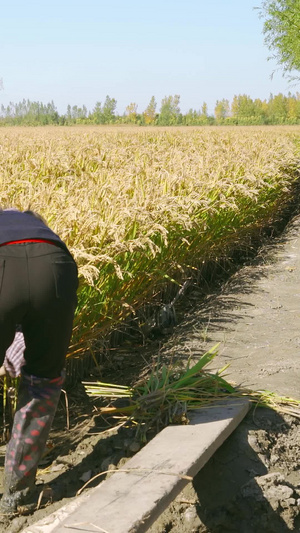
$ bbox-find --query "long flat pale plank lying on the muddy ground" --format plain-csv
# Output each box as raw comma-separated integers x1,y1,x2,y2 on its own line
23,398,249,533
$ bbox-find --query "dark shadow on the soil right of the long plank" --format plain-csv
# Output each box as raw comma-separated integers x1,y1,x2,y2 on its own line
193,411,291,533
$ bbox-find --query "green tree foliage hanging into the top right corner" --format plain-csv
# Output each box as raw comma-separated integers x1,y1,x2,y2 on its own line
260,0,300,78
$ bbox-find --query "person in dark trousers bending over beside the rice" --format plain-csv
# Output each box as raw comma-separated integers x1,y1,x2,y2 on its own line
0,209,78,515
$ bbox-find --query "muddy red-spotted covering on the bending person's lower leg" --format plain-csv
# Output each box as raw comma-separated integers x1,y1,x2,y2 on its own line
0,372,64,515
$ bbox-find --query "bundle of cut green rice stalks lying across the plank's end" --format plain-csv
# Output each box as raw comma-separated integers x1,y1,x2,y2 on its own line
83,346,300,440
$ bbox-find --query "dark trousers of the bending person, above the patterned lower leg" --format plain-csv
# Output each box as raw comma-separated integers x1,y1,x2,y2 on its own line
0,243,78,378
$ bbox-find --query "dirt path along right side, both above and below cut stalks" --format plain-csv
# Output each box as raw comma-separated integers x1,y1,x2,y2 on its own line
150,216,300,533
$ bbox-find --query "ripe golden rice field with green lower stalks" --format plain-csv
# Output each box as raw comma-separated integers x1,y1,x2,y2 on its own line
0,127,300,356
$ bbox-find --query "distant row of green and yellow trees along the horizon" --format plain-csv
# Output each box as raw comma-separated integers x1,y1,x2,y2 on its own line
0,92,300,126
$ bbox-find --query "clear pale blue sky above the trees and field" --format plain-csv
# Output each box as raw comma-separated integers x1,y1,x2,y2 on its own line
0,0,299,113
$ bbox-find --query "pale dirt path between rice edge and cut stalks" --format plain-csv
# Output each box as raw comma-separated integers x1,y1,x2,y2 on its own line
157,213,300,398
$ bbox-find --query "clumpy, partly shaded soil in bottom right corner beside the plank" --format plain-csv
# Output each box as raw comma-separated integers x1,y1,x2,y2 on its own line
149,408,300,533
